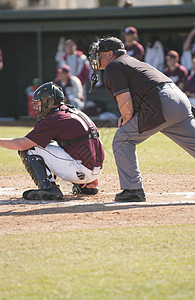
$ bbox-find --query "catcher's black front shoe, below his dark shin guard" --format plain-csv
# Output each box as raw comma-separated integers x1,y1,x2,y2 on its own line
23,182,63,200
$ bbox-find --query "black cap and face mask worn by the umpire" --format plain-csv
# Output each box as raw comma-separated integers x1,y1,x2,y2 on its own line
89,37,126,93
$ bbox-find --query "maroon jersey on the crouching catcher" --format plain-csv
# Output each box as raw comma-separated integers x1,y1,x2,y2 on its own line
26,106,104,170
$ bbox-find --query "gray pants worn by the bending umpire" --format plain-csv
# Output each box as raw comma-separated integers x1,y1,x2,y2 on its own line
113,83,195,189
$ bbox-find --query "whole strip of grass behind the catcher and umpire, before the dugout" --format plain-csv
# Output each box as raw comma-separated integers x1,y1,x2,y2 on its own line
0,126,195,175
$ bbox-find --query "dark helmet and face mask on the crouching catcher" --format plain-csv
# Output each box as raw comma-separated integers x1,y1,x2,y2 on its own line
32,82,64,120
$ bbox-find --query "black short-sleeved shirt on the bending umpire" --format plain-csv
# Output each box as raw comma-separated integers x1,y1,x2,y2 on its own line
104,54,172,133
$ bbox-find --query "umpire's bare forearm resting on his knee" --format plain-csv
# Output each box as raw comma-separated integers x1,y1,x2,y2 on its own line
116,92,133,127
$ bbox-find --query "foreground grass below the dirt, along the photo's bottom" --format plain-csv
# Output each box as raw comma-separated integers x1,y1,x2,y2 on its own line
0,225,195,300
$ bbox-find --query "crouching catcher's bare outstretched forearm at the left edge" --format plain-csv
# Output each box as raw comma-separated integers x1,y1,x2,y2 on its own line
0,137,36,151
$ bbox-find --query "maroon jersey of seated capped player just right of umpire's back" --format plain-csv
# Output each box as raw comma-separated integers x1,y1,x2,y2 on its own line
164,64,188,85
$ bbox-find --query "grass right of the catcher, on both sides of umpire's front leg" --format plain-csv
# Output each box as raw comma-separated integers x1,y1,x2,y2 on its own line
100,128,195,174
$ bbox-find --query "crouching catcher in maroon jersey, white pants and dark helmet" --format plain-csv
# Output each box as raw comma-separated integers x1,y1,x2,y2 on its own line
0,82,104,200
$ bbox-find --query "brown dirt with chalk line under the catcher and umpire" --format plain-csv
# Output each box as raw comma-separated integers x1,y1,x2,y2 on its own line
0,174,195,234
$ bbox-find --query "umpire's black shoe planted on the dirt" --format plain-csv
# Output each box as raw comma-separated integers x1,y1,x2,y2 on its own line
115,189,146,202
